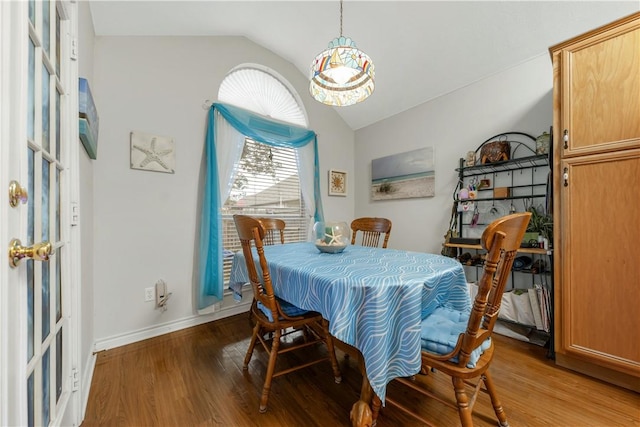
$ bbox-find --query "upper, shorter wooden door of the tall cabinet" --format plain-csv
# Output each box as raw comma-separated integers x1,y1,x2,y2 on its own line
561,21,640,156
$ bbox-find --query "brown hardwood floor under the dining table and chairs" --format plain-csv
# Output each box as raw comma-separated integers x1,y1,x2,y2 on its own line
82,314,640,427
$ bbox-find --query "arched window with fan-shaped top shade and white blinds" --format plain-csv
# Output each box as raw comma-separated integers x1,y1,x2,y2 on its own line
218,64,310,283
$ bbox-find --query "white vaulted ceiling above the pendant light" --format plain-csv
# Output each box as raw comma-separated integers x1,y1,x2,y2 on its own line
90,0,640,130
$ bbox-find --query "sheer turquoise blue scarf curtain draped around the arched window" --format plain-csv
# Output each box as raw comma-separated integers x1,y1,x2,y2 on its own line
197,103,323,310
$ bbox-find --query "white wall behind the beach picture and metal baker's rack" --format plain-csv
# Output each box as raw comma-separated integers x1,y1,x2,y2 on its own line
355,54,553,253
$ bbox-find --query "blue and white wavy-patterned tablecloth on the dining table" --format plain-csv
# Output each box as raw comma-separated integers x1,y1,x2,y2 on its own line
230,242,471,402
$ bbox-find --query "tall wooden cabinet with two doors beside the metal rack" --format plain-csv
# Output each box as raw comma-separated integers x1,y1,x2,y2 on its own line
549,13,640,391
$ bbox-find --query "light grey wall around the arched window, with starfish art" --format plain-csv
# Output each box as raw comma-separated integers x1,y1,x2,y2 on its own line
92,37,354,349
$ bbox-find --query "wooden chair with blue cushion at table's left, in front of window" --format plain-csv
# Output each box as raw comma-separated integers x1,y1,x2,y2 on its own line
233,215,342,413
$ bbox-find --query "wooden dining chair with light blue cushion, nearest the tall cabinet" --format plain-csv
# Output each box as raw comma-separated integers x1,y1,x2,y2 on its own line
372,212,531,427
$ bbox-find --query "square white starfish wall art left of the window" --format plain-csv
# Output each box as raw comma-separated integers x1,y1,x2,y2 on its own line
131,131,176,173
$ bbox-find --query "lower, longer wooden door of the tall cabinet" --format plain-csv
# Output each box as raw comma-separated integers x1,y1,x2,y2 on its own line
557,149,640,376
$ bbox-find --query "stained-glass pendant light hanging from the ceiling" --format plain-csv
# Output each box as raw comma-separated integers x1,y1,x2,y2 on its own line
309,0,375,107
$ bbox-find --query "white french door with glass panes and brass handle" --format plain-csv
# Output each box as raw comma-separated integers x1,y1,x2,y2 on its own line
0,0,77,426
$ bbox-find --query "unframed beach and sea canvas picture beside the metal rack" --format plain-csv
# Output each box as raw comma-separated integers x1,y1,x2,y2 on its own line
371,147,435,200
